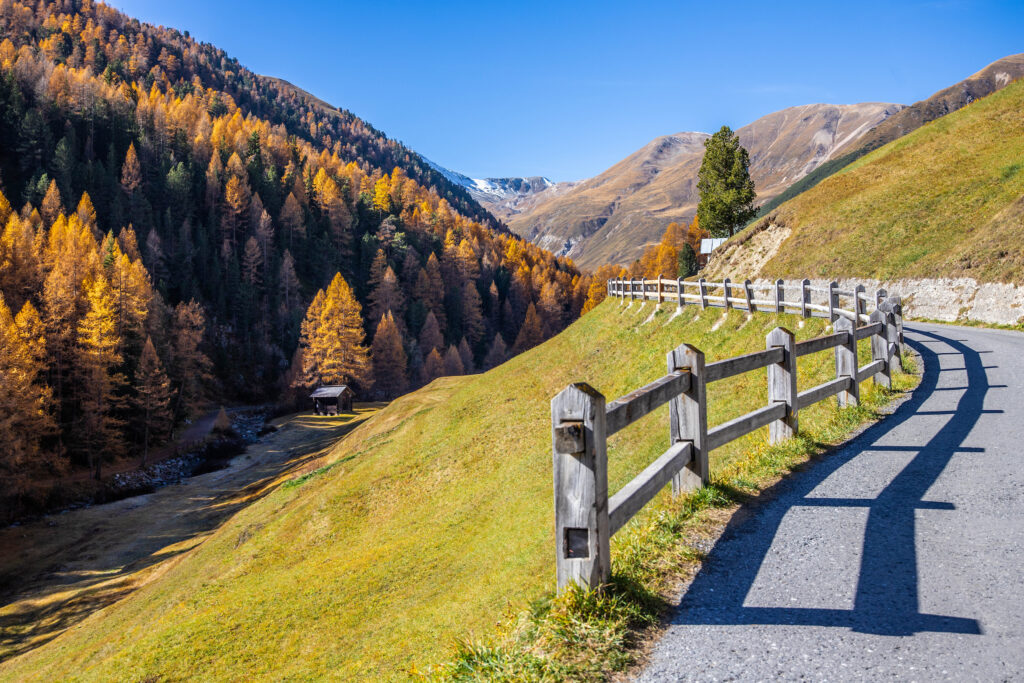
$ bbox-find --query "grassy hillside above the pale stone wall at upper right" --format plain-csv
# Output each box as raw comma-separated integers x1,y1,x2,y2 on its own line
749,80,1024,284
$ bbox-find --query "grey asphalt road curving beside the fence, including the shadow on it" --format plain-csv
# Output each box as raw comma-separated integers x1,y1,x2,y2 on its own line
639,323,1024,682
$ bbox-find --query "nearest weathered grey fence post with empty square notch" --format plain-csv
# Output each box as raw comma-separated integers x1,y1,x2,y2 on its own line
551,383,611,593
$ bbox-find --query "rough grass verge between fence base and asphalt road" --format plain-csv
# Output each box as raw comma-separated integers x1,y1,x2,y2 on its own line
424,354,920,681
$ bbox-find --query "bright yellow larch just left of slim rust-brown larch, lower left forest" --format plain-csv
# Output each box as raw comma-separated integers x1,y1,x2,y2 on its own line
76,275,125,479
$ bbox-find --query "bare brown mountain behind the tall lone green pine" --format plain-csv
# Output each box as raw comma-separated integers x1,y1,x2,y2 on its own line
509,102,902,267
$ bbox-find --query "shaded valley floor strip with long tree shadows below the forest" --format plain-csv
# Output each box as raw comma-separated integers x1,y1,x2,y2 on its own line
0,404,379,661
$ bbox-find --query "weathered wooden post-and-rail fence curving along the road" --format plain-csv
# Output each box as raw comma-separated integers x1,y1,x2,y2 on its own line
551,278,903,592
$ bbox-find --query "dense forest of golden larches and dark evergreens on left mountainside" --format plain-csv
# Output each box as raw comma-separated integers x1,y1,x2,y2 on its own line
0,0,604,501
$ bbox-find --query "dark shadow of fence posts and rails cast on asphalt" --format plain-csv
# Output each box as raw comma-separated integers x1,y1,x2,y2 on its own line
672,330,993,636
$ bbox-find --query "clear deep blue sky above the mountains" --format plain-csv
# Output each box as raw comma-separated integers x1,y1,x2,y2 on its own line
111,0,1024,180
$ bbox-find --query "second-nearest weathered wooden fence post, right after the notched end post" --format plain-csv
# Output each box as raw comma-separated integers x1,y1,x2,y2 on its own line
667,344,709,496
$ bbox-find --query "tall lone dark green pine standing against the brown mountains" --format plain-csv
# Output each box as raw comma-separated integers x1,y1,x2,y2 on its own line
697,126,757,238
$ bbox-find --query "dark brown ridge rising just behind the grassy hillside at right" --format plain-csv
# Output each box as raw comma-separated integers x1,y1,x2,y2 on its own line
760,54,1024,215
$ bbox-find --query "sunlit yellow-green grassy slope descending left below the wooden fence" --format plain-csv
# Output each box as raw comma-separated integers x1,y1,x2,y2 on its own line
0,301,876,680
